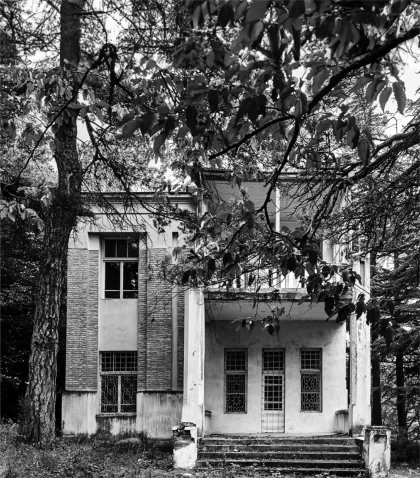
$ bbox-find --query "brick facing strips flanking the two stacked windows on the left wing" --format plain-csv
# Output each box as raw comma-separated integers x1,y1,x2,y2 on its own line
66,237,184,391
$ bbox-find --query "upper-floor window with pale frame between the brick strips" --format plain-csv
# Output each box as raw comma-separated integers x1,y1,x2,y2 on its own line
104,238,139,299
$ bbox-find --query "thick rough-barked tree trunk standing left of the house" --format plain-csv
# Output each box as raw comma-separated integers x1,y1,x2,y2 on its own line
22,0,84,443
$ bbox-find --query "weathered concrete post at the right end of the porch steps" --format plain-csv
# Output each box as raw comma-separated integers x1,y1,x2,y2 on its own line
363,426,391,478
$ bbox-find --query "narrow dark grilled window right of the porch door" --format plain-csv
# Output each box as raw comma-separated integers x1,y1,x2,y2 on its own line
300,349,322,412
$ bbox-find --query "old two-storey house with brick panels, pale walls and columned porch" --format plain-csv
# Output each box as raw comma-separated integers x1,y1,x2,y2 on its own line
62,173,370,438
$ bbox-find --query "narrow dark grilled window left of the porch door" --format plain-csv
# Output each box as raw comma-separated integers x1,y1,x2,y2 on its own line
225,349,247,413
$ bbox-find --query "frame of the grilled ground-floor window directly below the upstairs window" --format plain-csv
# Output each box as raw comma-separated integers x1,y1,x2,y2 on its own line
99,350,138,415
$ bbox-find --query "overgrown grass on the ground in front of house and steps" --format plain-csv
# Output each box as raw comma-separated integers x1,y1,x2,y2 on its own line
0,423,420,478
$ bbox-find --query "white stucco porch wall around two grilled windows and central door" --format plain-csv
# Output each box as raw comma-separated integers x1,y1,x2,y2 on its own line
204,321,347,433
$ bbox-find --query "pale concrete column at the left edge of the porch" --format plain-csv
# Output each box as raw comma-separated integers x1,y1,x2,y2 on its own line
181,289,205,436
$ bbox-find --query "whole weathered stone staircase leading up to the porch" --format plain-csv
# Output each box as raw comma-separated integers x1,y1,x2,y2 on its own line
197,436,368,477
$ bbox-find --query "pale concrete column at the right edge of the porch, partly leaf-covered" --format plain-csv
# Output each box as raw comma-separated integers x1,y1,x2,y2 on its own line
349,263,371,436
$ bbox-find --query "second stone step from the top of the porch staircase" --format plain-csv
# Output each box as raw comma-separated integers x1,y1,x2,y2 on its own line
199,443,359,453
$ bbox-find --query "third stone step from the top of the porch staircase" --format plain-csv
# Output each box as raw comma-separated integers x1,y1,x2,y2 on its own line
198,450,360,461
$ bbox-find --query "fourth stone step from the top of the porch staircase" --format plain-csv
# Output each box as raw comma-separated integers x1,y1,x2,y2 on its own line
197,458,364,472
